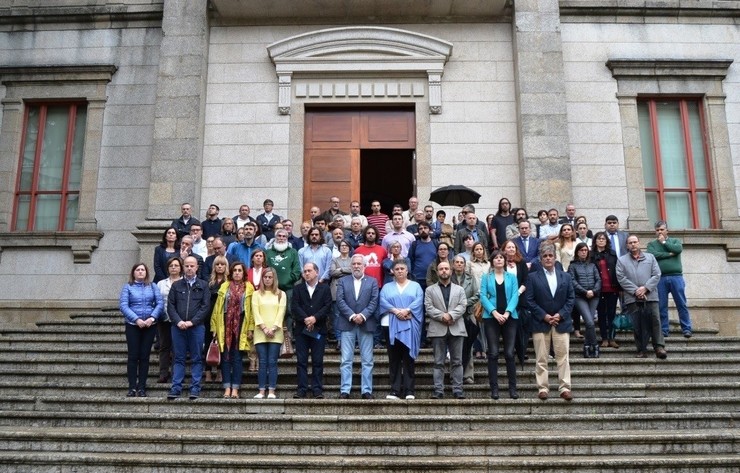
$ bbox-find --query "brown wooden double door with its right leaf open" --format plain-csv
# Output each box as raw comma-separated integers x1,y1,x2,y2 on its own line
303,109,416,214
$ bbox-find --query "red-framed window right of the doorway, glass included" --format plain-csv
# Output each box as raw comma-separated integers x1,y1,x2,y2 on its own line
637,98,716,229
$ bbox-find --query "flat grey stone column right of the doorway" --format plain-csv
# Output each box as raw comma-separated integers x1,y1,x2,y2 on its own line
513,0,577,212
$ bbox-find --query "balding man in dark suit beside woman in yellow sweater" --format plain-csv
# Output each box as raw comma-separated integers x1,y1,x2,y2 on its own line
290,263,331,399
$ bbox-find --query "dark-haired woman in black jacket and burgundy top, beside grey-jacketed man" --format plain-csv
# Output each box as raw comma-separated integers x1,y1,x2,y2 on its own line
591,232,621,348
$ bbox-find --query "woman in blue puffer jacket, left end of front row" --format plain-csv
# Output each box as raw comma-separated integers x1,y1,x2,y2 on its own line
119,263,164,397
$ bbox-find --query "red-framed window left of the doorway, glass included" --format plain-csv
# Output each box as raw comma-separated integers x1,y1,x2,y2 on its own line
12,103,87,231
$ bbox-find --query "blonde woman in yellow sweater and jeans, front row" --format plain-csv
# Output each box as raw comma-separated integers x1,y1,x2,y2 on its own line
252,268,287,399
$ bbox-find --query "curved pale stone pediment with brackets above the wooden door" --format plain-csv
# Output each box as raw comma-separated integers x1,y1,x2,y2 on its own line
267,26,452,115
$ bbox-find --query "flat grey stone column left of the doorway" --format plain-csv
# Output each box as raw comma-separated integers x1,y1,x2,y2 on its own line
134,0,209,261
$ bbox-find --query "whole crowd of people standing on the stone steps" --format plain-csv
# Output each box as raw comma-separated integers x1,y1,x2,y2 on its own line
120,196,692,401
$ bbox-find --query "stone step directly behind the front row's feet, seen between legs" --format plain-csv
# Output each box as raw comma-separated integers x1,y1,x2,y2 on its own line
0,376,740,399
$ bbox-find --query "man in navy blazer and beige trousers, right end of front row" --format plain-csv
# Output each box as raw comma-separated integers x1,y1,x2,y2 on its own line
525,244,575,401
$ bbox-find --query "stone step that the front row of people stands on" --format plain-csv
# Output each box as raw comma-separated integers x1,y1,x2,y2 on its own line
7,391,740,414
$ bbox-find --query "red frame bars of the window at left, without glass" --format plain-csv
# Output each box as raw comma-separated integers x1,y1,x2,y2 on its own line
11,102,87,231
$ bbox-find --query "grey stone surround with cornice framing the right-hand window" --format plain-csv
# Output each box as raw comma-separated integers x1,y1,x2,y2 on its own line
605,58,740,238
